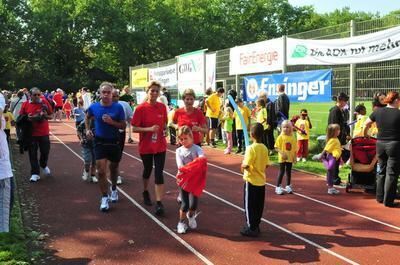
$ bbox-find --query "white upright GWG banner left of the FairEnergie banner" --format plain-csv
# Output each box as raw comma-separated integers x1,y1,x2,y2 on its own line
177,50,205,96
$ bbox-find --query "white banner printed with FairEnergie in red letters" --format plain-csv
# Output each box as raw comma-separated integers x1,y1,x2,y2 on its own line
229,38,283,75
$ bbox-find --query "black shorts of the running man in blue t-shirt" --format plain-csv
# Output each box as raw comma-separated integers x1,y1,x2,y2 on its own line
94,138,122,163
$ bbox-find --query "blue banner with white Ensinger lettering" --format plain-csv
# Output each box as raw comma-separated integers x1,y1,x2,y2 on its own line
243,69,332,102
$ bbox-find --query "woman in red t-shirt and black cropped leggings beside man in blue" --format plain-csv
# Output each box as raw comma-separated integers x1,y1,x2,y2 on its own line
131,81,168,216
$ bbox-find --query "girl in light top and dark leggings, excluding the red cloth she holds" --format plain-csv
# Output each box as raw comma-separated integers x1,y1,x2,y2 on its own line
176,125,204,234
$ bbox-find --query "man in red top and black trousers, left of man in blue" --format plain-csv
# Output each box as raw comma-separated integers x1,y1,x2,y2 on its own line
19,87,53,182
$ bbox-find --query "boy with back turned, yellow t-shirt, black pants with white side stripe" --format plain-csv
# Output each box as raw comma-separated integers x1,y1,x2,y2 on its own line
240,123,269,237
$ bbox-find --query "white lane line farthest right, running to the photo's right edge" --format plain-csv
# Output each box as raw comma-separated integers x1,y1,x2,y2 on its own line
64,123,400,231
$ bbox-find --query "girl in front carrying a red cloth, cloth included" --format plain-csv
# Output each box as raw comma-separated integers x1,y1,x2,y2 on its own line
176,125,207,234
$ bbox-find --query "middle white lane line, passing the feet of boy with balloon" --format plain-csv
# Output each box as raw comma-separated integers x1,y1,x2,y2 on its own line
124,152,359,265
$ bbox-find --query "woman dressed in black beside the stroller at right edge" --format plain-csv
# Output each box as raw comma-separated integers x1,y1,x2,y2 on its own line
364,92,400,207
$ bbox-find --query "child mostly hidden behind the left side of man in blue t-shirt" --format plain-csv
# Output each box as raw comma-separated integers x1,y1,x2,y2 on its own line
77,121,98,183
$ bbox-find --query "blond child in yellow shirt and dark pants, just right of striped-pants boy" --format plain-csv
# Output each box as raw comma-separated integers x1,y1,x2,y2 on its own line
275,120,297,195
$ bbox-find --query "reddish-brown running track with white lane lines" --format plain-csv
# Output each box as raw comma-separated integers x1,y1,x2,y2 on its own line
18,122,400,264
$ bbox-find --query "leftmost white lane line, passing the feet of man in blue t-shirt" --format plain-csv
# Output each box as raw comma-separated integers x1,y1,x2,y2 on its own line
50,132,214,265
